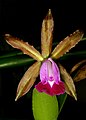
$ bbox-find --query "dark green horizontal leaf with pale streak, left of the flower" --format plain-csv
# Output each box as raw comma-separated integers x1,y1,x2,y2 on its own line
0,55,34,69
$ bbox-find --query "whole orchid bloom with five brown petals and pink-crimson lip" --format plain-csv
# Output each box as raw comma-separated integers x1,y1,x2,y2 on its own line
5,9,83,100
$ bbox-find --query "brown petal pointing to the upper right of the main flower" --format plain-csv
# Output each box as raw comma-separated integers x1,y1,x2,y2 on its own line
51,30,84,59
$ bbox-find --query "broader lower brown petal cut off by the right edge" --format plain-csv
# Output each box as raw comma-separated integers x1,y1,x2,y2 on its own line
74,65,86,82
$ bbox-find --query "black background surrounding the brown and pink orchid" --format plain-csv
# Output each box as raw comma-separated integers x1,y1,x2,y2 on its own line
0,0,86,120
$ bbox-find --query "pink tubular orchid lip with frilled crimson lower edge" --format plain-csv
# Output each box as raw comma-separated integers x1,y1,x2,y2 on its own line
35,58,65,96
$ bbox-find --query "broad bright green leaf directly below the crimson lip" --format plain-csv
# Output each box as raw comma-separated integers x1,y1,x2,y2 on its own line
32,89,59,120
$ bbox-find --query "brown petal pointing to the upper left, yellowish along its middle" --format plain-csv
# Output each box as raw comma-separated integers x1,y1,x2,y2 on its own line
5,34,43,61
